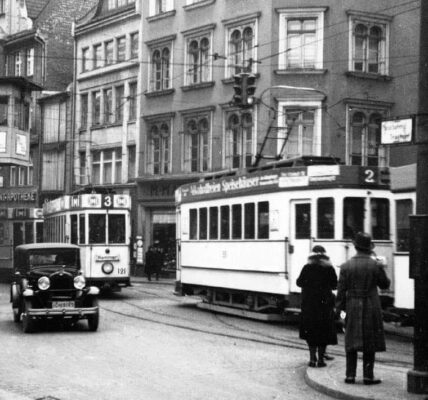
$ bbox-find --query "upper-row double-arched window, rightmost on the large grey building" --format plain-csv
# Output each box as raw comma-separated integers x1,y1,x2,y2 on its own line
350,16,388,75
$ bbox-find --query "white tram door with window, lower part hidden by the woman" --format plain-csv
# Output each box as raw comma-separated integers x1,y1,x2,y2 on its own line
288,200,312,292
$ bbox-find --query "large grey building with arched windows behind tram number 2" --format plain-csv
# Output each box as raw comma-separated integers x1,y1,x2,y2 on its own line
137,0,419,262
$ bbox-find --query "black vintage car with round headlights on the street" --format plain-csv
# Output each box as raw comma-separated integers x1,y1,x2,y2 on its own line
10,243,99,333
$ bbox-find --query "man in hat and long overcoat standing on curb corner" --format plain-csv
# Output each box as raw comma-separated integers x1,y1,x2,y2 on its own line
336,232,390,385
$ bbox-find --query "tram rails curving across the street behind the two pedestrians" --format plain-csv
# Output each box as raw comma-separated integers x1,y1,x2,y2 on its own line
102,289,411,367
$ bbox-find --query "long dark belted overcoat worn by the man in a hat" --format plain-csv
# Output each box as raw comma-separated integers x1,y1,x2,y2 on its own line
336,252,390,352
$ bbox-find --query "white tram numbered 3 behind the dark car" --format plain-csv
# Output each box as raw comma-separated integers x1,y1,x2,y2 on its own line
43,193,131,290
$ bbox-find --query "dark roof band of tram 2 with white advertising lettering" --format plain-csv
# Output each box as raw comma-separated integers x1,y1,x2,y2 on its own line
176,157,390,203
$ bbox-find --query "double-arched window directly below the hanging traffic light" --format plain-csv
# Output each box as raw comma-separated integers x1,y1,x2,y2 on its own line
225,112,254,168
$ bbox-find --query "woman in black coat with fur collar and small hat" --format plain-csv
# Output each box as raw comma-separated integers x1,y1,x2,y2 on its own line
296,242,337,367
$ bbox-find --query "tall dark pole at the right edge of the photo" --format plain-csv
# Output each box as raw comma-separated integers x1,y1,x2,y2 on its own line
407,1,428,394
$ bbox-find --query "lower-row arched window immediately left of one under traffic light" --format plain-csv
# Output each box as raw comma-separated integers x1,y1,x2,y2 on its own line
184,116,210,172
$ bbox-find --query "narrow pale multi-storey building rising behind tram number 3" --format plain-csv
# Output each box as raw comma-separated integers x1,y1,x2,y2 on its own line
73,0,141,238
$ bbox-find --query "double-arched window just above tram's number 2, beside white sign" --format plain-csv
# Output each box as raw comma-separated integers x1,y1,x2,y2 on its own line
348,110,386,166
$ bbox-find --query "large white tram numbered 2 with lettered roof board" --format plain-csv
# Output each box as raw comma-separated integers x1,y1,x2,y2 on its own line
175,157,395,319
